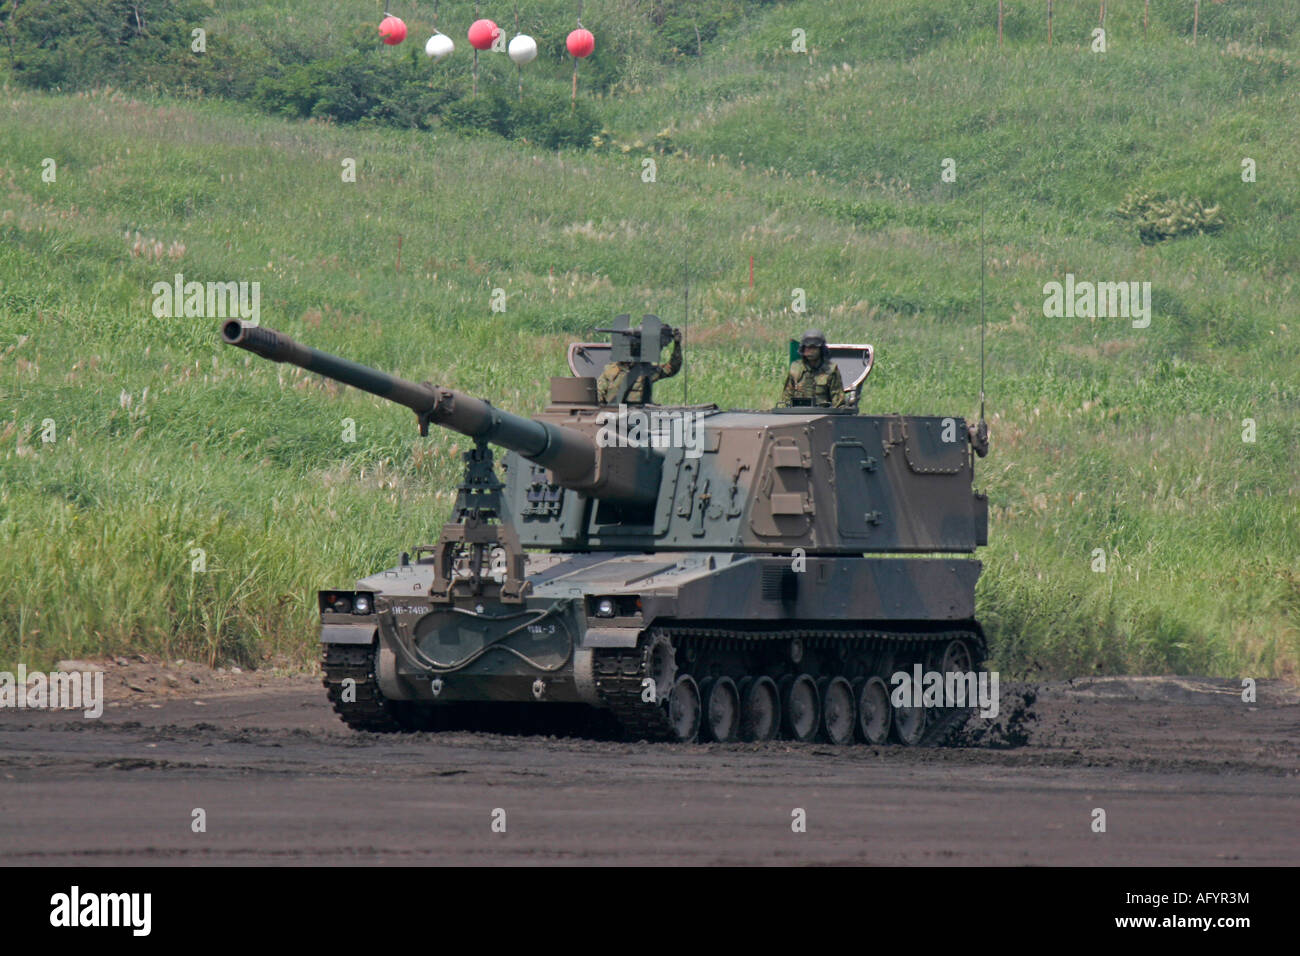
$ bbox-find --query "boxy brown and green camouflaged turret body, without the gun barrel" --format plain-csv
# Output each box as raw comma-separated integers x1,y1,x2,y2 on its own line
507,412,987,554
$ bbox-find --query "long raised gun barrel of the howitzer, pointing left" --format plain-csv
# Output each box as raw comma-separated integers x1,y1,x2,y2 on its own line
221,319,658,501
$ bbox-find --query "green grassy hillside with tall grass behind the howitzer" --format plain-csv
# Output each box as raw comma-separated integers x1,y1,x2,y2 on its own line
0,0,1300,676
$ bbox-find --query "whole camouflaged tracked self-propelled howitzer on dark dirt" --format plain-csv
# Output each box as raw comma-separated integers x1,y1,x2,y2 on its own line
222,316,988,744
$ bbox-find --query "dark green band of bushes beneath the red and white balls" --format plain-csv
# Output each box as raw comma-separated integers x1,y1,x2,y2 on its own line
0,0,600,150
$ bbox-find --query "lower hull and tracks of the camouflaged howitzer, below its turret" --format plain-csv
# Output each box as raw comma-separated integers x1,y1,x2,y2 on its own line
321,551,985,744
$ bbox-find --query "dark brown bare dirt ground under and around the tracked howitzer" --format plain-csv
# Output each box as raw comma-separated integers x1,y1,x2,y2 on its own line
0,658,1300,865
